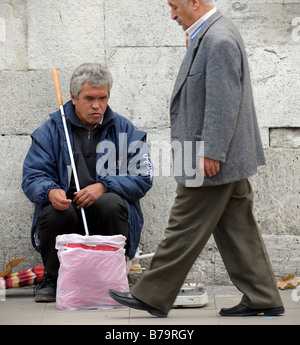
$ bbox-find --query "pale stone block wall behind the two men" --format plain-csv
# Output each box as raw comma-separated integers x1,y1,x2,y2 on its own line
0,0,300,284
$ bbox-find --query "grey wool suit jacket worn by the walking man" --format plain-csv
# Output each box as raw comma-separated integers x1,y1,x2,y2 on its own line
170,11,265,187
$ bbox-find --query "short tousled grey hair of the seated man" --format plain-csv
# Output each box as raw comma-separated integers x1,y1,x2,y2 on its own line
70,63,113,99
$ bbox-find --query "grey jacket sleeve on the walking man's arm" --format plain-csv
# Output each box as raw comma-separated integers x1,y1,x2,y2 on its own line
202,37,242,162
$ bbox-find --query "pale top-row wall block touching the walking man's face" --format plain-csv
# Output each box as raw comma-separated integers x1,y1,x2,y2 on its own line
105,0,185,47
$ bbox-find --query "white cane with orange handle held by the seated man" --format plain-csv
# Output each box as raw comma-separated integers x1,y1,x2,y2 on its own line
52,68,89,236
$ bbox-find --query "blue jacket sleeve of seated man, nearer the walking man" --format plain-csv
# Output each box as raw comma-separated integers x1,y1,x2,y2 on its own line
97,132,153,203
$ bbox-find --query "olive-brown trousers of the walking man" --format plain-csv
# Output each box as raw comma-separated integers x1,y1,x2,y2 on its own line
131,179,282,313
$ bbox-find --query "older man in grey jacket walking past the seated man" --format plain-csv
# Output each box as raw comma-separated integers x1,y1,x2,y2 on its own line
110,0,284,317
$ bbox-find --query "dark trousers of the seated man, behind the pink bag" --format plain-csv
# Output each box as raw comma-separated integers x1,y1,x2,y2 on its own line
39,193,128,279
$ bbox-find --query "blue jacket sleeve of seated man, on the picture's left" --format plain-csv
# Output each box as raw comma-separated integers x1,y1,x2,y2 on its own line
22,129,61,204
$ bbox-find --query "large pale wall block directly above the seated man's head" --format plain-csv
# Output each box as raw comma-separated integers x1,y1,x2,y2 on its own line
27,0,105,69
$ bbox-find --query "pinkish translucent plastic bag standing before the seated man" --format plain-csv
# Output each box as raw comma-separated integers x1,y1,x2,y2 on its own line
56,234,129,310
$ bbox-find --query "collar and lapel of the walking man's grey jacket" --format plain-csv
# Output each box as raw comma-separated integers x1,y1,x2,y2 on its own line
171,10,223,103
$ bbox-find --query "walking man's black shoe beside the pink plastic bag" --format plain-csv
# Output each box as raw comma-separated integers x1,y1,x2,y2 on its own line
108,290,168,317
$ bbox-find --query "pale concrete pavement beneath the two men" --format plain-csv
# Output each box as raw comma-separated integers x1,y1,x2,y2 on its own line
0,285,300,328
